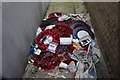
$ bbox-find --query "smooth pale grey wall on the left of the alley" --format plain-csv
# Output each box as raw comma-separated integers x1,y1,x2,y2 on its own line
2,2,48,78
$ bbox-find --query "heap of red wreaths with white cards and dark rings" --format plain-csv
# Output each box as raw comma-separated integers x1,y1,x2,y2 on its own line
30,12,99,74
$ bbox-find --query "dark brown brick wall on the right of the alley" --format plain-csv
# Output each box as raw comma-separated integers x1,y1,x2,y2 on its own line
85,2,120,78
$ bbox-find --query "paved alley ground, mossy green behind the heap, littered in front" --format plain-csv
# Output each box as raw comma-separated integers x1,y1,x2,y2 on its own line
24,2,109,78
